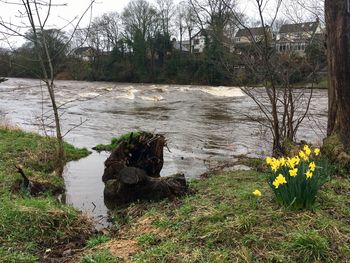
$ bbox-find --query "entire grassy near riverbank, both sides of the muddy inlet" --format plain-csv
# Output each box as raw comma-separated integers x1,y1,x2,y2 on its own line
0,127,350,262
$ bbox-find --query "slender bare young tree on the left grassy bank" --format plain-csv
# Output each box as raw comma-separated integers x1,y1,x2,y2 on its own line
0,0,94,174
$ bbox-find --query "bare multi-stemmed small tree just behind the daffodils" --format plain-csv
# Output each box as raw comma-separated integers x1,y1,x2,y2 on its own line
227,0,315,156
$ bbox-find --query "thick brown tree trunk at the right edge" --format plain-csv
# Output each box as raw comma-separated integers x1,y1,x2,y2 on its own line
325,0,350,150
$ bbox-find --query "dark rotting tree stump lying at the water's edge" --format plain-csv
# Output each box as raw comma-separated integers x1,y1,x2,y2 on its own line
102,133,188,204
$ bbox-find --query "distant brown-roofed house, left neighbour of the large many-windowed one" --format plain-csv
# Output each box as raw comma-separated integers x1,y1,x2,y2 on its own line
234,27,273,47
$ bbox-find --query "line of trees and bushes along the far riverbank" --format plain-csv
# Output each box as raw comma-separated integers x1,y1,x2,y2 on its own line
0,0,325,85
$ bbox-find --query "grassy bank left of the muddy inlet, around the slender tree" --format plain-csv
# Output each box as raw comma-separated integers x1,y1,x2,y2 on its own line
0,126,91,263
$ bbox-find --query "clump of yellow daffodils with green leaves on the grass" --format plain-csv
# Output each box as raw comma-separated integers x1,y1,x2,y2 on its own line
266,145,331,209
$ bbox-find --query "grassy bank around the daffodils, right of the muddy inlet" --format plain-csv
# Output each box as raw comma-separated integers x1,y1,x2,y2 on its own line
81,171,350,262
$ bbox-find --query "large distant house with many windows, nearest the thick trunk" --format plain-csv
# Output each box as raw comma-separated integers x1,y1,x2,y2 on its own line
276,20,322,56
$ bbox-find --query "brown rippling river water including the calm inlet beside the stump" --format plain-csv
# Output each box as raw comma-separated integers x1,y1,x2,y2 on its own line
0,78,327,225
